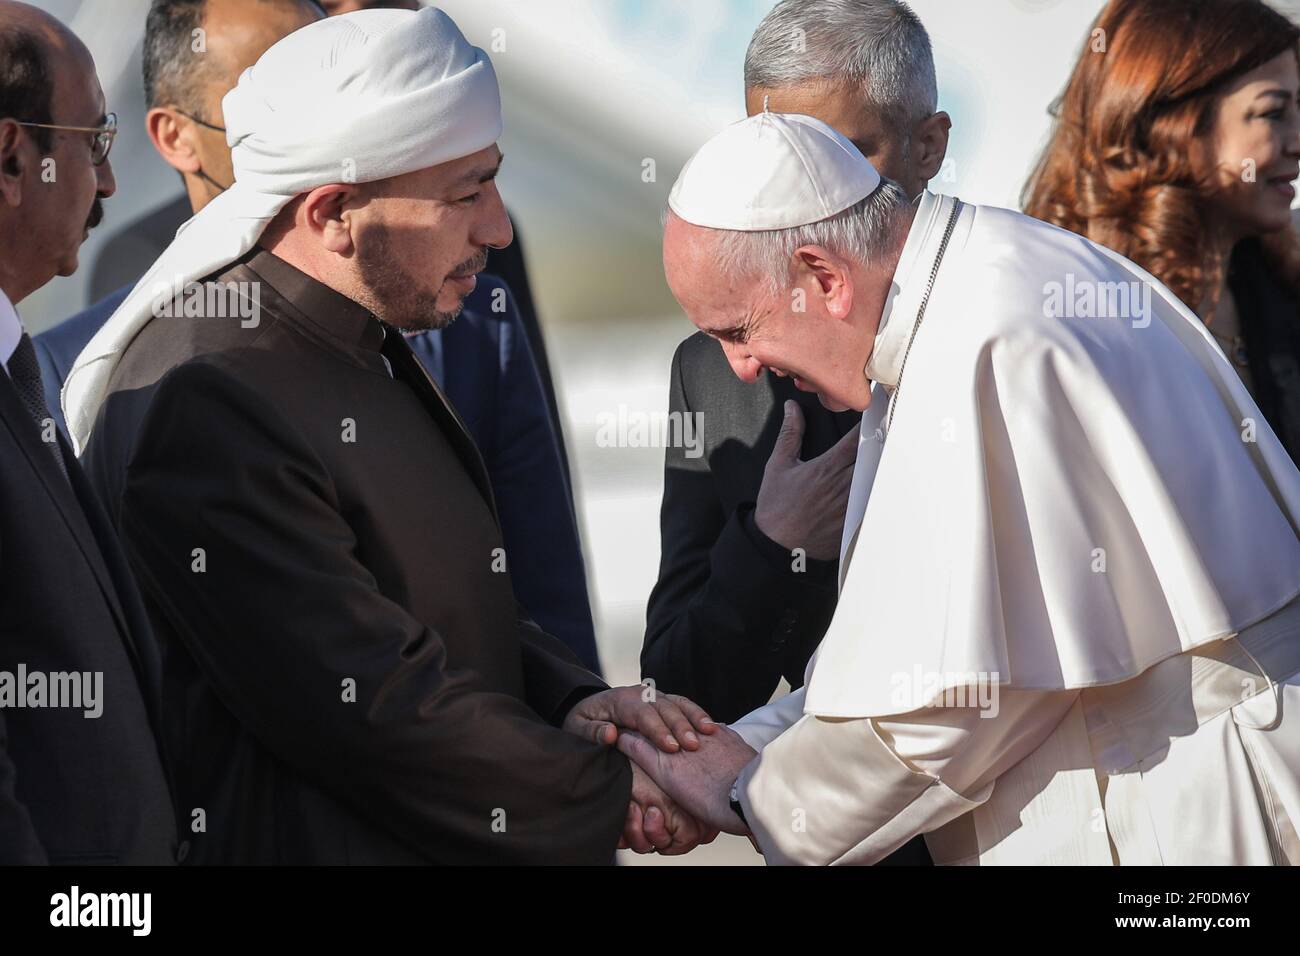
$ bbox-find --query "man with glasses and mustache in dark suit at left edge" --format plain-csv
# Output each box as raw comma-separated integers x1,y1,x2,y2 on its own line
0,1,178,864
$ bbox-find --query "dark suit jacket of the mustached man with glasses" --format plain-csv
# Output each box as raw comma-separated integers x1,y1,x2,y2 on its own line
0,368,177,864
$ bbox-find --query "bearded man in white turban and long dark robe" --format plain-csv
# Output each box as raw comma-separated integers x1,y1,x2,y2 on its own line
65,8,714,864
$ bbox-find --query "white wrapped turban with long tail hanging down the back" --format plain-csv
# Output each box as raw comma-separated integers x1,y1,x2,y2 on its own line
62,7,502,454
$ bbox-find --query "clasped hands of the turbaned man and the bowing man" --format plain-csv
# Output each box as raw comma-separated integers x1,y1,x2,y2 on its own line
563,684,758,856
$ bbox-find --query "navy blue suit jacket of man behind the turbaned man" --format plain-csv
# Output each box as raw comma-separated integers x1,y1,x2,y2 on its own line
34,274,601,674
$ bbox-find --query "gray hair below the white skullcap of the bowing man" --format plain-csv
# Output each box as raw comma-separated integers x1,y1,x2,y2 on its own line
714,178,911,295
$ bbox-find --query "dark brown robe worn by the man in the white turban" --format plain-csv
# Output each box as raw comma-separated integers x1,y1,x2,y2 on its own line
86,250,631,864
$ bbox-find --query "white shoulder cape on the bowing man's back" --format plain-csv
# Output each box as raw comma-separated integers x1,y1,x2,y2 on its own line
805,194,1300,718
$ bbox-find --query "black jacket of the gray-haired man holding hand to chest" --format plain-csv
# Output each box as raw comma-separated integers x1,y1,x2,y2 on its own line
641,332,861,721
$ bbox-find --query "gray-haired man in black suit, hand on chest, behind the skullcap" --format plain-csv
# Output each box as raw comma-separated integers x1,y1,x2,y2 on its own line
641,0,952,862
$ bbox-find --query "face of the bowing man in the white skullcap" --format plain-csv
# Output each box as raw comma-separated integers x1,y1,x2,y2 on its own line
663,213,883,411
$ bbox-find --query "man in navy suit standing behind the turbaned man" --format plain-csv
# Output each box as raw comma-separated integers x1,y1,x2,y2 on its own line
36,0,599,672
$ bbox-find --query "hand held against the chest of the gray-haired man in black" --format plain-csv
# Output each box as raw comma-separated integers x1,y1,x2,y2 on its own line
754,401,858,561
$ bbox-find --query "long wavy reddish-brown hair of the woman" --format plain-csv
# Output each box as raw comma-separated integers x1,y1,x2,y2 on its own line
1022,0,1300,310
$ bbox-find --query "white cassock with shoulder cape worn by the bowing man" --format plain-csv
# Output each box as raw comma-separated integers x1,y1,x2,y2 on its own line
733,193,1300,865
